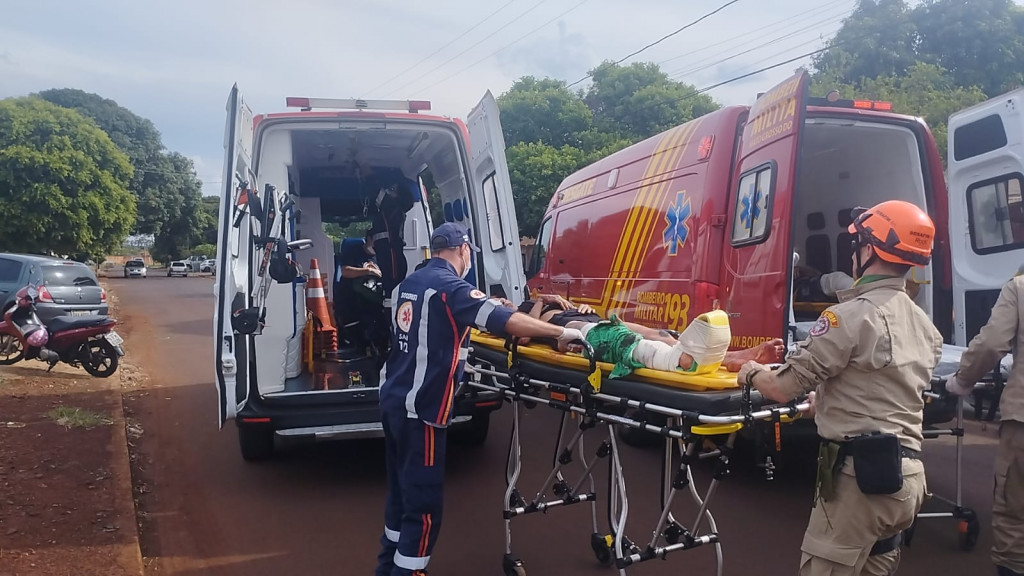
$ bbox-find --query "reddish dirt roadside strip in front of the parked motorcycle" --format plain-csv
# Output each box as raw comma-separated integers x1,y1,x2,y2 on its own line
0,284,142,576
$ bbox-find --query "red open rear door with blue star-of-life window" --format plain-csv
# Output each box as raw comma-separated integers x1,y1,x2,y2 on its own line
719,71,808,347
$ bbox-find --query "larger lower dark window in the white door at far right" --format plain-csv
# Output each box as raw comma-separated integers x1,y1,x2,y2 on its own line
967,172,1024,254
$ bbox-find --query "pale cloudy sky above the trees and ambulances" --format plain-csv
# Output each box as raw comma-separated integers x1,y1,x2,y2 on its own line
0,0,868,195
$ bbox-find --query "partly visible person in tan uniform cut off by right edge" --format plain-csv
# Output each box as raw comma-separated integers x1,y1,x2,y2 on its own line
946,269,1024,576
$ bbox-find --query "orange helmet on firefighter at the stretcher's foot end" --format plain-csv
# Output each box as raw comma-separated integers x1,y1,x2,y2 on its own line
849,200,935,266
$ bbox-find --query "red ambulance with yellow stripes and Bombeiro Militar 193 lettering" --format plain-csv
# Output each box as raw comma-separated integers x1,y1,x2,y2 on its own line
527,71,951,347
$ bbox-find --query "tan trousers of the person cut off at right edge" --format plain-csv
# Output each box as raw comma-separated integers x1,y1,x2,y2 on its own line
992,420,1024,573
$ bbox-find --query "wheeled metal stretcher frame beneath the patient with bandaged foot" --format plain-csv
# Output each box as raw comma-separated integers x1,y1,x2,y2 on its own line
466,340,810,576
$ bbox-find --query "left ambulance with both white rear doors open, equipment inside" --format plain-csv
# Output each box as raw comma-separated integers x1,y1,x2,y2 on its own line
214,86,525,460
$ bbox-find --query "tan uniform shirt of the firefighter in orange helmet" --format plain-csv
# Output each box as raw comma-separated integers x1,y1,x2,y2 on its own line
777,278,942,450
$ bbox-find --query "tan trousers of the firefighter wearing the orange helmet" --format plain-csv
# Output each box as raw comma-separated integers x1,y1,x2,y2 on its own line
800,458,927,576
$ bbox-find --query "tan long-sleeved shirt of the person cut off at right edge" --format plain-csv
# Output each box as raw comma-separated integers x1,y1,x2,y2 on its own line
956,276,1024,422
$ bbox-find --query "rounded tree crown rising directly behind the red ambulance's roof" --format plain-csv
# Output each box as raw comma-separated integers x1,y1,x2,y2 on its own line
584,61,719,141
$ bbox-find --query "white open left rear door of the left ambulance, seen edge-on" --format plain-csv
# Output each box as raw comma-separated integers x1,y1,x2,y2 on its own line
213,84,256,426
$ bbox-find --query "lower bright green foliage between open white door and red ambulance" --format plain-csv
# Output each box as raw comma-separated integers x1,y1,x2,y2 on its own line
505,142,585,236
